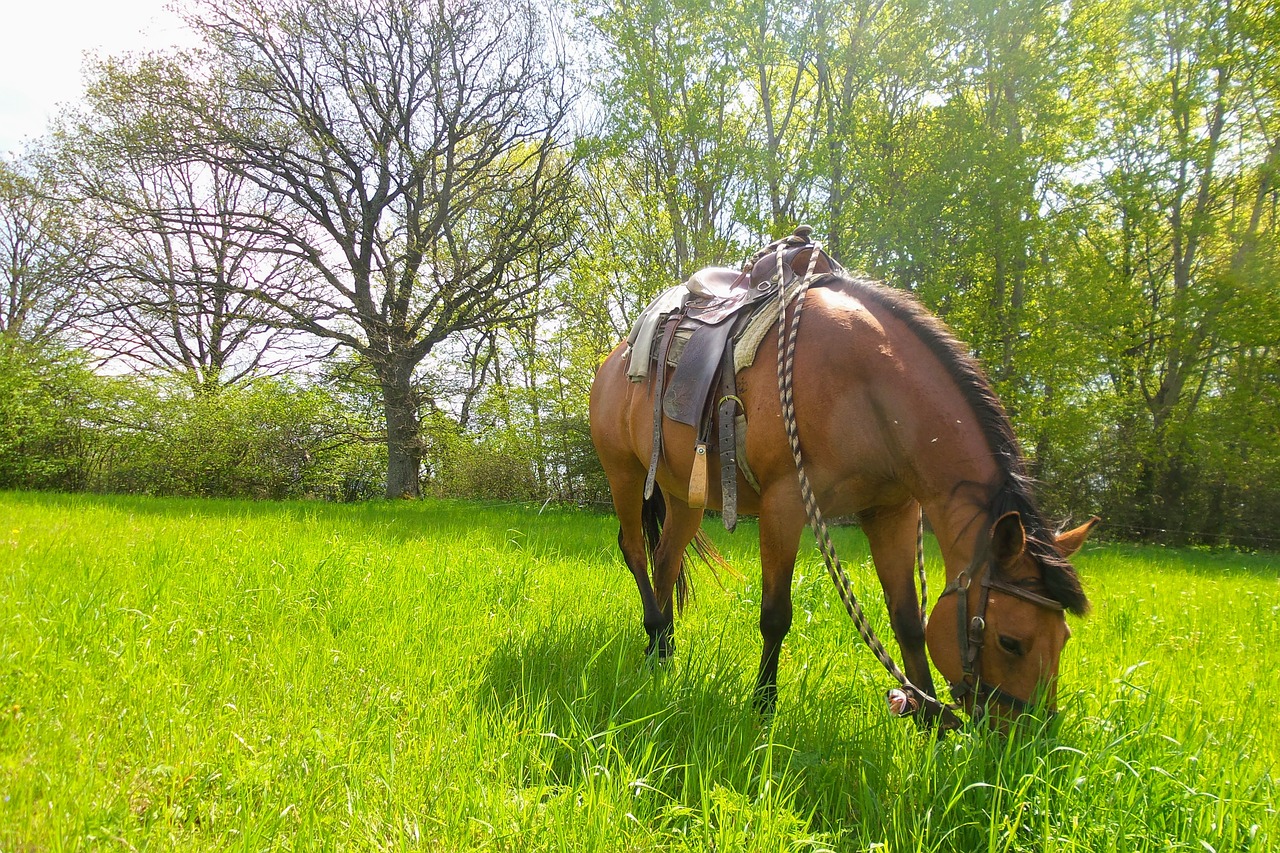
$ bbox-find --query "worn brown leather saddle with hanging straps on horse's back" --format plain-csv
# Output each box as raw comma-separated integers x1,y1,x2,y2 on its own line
627,225,841,530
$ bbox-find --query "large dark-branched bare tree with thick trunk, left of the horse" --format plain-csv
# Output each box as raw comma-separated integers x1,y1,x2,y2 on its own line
119,0,575,496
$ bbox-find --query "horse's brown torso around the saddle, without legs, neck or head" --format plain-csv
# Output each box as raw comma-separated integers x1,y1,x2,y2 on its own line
590,279,942,515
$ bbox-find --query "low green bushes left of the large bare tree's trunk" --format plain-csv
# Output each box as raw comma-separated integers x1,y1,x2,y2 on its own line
0,337,381,500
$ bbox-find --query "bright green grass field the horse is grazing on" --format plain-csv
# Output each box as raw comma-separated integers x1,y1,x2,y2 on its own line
0,493,1280,852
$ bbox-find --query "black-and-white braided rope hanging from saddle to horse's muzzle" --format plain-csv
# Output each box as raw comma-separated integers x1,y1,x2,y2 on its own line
774,243,960,727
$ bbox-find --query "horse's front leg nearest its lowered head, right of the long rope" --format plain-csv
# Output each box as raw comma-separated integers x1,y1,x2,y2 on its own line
860,501,936,695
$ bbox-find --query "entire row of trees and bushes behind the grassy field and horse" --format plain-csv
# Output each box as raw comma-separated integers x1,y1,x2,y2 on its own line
0,0,1280,547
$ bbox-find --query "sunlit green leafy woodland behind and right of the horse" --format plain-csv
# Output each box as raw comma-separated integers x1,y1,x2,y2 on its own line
567,0,1280,547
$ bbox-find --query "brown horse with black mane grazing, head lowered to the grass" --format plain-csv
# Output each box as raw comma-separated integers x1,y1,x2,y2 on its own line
590,273,1096,720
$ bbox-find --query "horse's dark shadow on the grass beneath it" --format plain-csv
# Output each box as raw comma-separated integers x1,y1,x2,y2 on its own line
474,616,1121,849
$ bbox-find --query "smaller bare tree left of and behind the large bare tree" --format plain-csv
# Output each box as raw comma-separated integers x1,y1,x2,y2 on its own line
55,68,314,392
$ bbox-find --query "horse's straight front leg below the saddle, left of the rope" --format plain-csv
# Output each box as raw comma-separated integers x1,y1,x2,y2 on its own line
755,496,804,715
